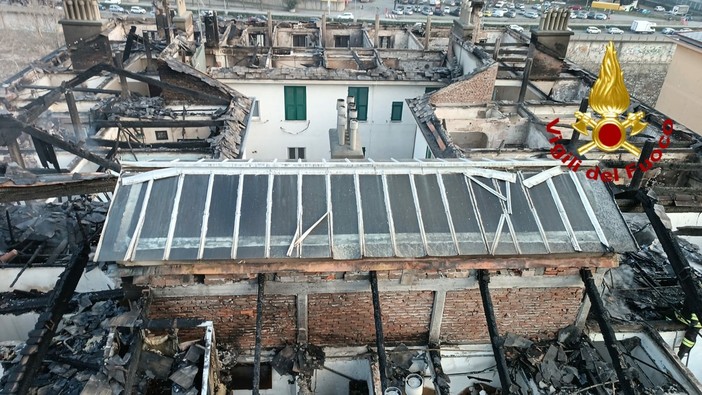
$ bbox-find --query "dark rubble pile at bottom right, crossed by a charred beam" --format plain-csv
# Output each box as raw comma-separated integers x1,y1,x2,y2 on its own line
504,326,684,395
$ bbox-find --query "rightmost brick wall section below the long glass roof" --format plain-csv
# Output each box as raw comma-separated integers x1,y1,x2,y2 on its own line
441,288,583,343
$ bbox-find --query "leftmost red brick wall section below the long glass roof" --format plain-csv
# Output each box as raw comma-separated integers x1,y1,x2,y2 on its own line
148,295,297,349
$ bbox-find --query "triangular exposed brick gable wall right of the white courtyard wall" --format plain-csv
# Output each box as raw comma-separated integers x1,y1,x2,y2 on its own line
429,63,497,105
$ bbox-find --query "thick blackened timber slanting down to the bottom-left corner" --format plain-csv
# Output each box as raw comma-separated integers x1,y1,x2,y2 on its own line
2,241,90,395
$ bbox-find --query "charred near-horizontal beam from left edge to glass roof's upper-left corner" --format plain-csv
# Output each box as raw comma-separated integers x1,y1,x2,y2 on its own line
0,176,117,203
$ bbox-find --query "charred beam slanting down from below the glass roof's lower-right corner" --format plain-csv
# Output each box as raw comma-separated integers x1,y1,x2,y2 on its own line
580,268,636,395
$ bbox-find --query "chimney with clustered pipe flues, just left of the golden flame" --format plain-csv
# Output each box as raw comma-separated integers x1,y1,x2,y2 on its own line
527,8,573,79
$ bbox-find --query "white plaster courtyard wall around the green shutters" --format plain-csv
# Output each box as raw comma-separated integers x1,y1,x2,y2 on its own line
223,80,430,160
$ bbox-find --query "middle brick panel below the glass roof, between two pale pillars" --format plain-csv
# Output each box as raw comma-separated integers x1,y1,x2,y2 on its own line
308,291,434,345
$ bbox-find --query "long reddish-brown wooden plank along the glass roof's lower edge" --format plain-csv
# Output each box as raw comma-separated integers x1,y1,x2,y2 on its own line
120,254,619,276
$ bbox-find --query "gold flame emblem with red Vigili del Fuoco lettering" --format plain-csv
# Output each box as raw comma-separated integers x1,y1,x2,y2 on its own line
546,41,673,181
